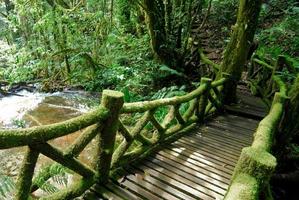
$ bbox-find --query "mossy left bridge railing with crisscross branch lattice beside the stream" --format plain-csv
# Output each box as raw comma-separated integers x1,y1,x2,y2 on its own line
0,75,228,200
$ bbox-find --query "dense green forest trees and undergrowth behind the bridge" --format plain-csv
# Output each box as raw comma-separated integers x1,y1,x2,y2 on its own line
0,0,299,199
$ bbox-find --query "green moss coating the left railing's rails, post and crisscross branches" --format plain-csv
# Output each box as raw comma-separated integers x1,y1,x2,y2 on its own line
0,78,227,199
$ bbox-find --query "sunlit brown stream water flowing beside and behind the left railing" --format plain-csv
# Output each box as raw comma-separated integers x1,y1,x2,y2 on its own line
0,91,98,199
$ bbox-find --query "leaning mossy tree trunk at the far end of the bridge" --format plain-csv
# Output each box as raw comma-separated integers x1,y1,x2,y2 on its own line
220,0,262,103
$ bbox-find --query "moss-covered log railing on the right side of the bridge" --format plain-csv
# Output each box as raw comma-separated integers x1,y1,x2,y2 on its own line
225,77,287,200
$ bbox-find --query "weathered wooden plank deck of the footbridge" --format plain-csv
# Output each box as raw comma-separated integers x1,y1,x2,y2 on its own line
79,91,266,200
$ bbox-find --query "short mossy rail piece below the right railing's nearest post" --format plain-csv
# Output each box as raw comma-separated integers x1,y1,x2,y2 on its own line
224,174,258,200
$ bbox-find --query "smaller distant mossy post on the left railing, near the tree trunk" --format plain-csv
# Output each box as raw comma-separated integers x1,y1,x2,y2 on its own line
196,78,212,122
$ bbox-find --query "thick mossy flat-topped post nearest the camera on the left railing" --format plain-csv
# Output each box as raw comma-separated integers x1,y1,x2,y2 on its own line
97,90,124,184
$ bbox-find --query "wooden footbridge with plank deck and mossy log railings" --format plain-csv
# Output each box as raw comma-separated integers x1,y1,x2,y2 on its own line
0,74,286,200
